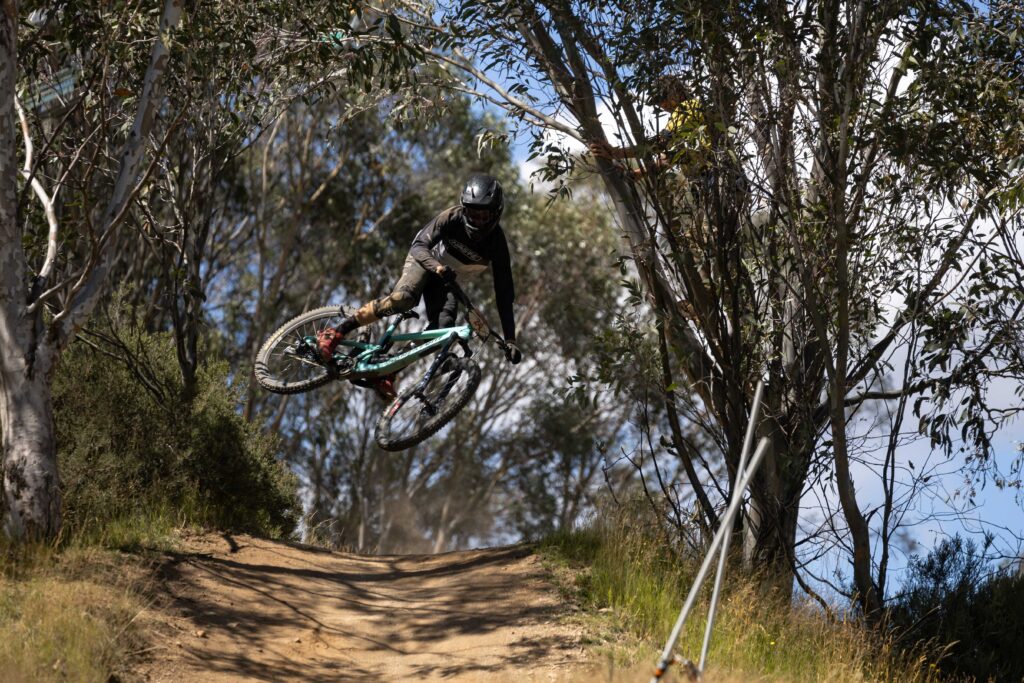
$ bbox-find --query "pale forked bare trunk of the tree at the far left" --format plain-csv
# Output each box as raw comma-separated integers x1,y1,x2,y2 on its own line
0,0,181,540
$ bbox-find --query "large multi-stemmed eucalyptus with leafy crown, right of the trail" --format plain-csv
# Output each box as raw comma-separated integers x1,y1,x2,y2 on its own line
348,0,1022,610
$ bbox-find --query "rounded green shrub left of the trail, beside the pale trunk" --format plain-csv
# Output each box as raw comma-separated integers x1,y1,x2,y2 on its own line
53,328,299,536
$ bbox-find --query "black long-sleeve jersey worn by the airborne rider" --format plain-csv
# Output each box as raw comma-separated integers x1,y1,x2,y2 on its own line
409,206,515,340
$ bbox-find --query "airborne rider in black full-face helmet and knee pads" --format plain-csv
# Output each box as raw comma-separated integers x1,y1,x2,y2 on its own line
317,173,522,398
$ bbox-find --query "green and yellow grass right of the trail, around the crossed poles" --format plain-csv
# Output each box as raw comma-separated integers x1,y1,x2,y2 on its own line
540,511,940,682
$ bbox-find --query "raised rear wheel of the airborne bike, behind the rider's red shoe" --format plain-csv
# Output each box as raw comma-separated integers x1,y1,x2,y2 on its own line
253,306,352,393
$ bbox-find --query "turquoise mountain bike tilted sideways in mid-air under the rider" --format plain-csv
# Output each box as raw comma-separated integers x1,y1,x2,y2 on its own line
254,283,511,451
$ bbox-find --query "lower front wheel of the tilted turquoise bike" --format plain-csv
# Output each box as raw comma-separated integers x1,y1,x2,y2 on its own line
374,356,480,451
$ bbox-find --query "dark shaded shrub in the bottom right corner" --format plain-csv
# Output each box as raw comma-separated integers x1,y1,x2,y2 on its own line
890,536,1024,681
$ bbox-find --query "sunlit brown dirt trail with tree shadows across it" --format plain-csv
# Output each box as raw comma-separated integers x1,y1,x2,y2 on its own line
135,536,584,681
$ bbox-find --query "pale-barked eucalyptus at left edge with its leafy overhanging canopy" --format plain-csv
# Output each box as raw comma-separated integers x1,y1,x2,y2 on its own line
0,0,408,537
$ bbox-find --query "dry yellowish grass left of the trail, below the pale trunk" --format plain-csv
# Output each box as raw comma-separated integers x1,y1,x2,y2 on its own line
0,510,184,683
